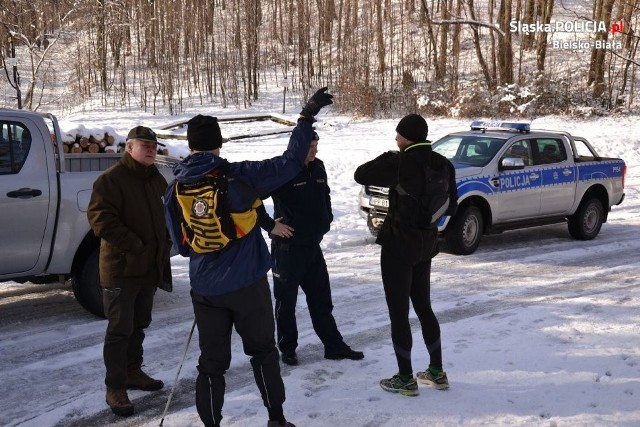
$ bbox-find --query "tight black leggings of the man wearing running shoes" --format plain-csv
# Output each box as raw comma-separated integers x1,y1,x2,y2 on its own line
380,247,442,375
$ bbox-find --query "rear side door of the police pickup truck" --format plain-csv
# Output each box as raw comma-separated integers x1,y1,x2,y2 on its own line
534,138,577,216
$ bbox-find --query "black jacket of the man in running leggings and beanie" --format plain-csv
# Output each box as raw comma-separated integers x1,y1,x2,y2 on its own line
354,142,458,263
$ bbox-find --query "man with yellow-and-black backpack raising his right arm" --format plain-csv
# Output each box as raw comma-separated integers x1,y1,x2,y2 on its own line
165,87,333,427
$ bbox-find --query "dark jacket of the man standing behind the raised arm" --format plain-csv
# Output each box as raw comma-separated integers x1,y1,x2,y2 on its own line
271,158,333,245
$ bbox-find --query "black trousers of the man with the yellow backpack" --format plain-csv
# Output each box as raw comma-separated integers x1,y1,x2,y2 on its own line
191,276,285,426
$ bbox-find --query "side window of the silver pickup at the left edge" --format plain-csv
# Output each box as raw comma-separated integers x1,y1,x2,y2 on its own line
0,122,31,175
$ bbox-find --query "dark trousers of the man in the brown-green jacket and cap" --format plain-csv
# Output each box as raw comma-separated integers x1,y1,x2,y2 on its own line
102,286,156,389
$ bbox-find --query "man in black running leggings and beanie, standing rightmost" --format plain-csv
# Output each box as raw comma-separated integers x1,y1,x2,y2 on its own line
354,114,458,396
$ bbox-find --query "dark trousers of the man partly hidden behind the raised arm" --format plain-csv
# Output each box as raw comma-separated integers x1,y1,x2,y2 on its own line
271,241,346,353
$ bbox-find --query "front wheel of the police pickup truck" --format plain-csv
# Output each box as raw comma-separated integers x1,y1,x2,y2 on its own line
445,206,484,255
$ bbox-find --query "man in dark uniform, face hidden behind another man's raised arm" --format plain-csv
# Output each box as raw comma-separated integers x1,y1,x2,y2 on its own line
271,132,364,365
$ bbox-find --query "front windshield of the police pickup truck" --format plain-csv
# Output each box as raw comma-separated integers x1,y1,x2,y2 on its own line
433,135,506,166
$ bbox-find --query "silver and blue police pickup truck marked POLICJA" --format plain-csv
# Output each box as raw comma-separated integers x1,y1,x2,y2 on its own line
359,121,626,255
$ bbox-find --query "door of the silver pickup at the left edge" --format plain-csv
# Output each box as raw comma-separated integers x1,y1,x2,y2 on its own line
0,120,51,275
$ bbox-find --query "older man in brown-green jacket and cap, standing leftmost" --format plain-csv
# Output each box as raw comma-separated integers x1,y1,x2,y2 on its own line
87,126,171,417
